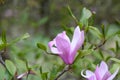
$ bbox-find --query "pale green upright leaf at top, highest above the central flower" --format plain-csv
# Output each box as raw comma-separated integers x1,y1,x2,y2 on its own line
80,8,92,25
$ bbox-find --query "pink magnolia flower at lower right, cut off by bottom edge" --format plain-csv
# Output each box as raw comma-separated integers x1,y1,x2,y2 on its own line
81,61,119,80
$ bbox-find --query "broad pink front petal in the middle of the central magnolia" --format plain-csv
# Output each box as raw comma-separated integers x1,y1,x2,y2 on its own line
55,36,70,64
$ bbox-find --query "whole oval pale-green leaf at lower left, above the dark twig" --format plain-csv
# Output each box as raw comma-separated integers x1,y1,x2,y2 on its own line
5,60,16,76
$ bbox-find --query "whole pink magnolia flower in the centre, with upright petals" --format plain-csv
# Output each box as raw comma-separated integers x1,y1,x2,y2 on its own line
48,26,84,65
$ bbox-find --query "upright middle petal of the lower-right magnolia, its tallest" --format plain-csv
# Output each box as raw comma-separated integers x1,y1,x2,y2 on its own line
95,61,108,80
